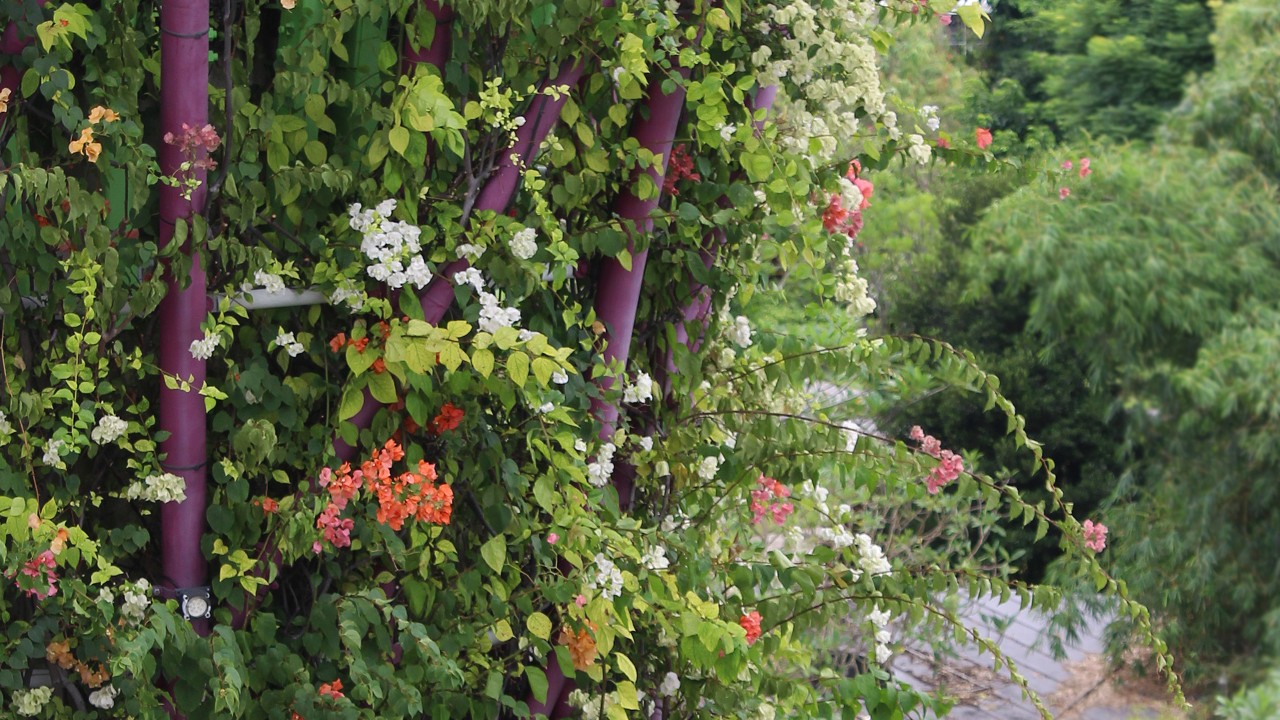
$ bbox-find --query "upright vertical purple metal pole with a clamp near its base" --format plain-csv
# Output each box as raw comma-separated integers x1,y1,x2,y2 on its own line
159,0,209,634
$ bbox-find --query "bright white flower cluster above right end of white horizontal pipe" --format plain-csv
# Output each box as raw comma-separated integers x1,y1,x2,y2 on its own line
347,200,431,288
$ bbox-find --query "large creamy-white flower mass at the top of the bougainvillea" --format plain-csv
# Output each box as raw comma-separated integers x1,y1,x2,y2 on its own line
751,0,886,165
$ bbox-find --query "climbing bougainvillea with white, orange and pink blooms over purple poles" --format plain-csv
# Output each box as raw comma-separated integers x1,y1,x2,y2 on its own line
0,0,1165,720
